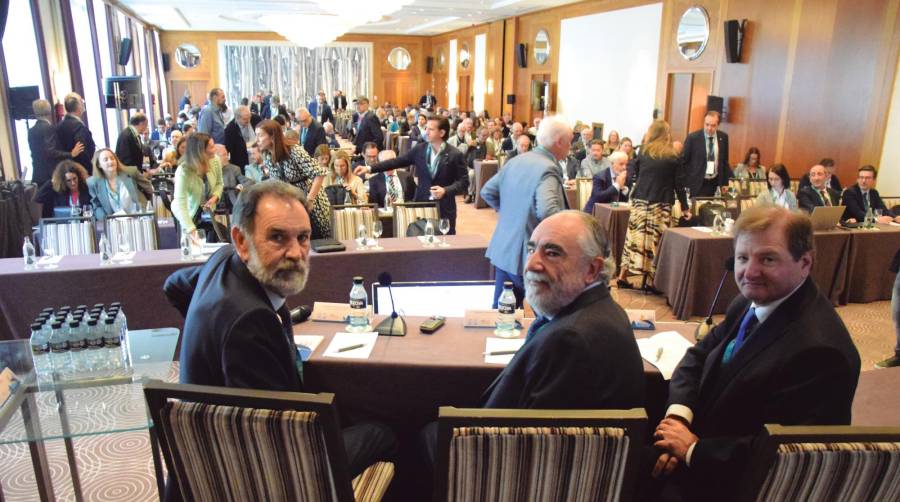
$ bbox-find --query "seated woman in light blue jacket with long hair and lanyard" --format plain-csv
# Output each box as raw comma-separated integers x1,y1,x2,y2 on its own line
87,148,153,220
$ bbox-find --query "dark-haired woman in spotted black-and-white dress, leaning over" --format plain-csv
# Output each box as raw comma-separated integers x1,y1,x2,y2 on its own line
256,120,332,239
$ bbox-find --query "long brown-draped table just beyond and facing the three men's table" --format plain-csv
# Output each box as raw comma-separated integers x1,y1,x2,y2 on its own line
0,235,491,340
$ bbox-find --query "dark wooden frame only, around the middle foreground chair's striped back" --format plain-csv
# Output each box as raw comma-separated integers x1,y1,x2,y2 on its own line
434,406,647,502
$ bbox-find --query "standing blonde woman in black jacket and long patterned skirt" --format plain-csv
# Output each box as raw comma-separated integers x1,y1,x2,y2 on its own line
616,120,691,291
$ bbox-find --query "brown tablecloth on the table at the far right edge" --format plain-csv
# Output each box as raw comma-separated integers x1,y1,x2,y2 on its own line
840,225,900,305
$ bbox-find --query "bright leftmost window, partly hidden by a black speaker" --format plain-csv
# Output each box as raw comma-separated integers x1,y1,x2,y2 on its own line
3,0,47,180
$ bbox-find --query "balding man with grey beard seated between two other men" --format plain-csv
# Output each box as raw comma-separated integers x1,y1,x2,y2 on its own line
482,211,644,409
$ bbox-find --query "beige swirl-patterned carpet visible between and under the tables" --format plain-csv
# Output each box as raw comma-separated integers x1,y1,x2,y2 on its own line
0,201,894,502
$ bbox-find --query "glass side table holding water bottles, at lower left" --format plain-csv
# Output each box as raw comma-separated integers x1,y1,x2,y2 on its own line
0,329,178,501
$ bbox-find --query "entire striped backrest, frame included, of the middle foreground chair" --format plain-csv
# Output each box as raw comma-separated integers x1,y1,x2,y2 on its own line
434,407,647,502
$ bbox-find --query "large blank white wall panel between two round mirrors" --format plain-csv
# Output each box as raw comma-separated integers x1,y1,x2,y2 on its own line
557,3,662,144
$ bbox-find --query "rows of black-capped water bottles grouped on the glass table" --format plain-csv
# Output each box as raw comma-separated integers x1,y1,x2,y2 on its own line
31,303,133,383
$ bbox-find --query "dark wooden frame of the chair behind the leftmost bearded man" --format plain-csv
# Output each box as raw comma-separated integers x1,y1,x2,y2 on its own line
144,380,354,502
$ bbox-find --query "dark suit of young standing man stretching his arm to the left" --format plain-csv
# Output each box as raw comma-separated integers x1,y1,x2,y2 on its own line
372,142,469,234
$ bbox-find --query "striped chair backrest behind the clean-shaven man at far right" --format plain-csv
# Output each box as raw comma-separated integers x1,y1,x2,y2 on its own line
740,425,900,502
